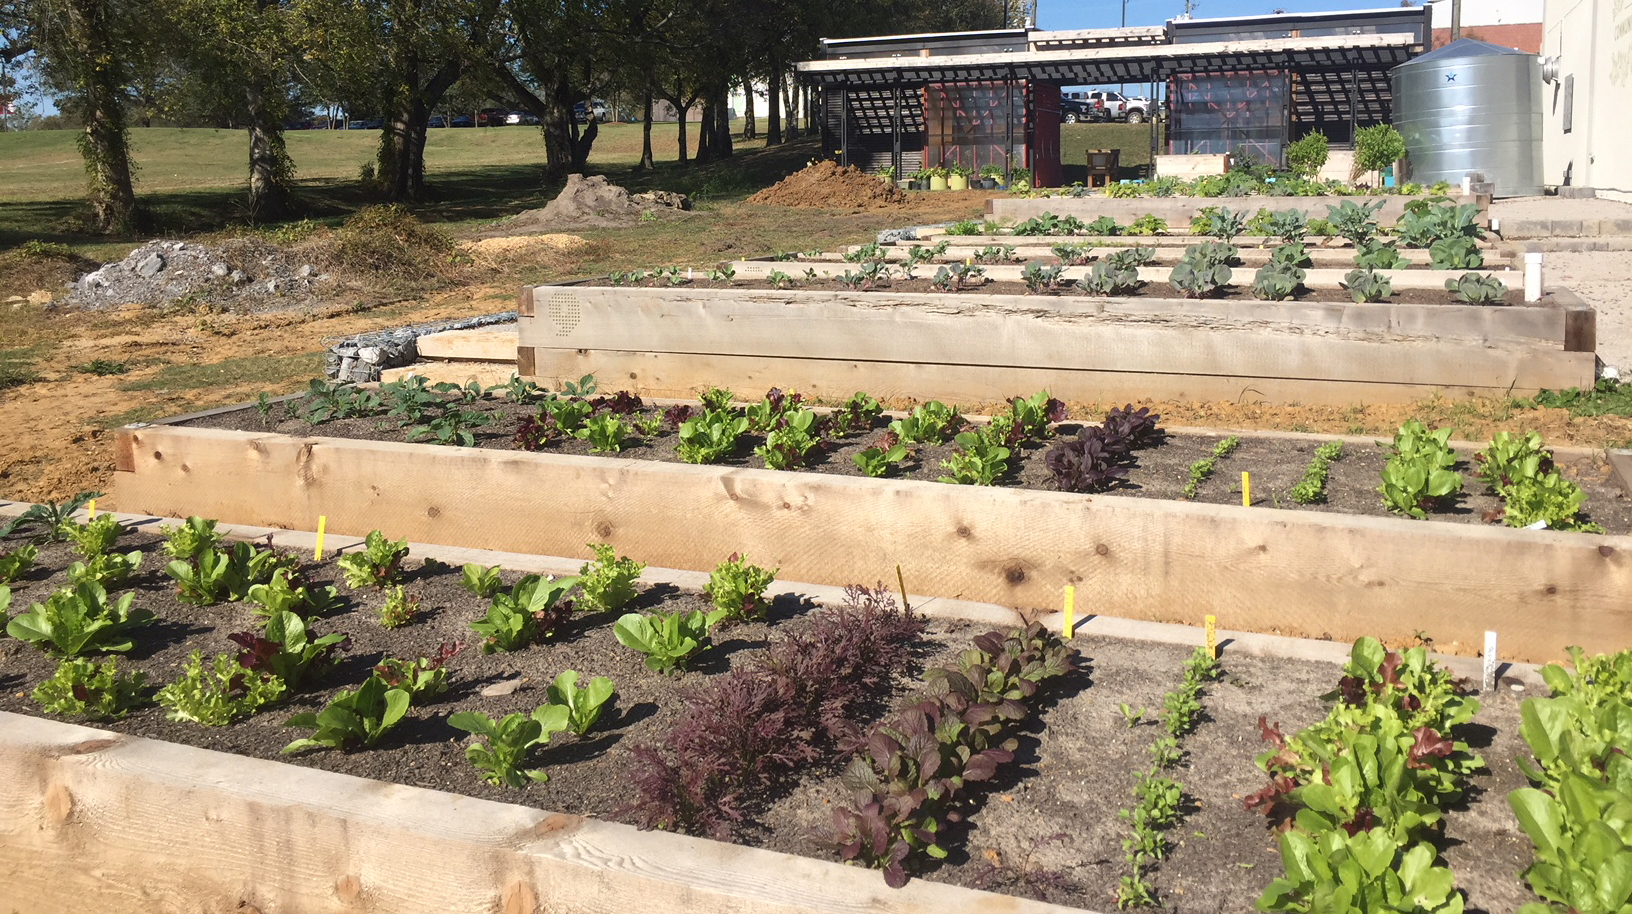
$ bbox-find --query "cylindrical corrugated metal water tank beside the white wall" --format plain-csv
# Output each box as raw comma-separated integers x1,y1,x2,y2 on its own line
1390,38,1542,197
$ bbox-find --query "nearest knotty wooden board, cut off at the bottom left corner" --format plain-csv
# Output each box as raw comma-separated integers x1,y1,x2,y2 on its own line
0,713,1080,914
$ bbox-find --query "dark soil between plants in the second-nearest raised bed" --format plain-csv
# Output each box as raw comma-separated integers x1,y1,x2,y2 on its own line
181,398,1632,534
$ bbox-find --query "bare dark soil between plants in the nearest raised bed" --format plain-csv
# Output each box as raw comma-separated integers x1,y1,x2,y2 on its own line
0,528,1531,914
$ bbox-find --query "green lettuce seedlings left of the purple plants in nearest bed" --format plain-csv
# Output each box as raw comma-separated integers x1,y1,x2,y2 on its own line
0,506,793,785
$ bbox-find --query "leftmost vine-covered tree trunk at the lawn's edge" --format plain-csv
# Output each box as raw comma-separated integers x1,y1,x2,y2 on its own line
69,0,135,233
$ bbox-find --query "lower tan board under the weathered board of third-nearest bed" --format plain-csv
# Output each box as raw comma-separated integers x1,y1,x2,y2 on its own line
524,349,1540,406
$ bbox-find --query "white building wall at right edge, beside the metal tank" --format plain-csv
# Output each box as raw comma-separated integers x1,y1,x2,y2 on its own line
1542,0,1632,191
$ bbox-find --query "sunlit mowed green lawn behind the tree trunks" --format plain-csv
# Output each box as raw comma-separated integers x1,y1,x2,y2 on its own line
0,122,789,249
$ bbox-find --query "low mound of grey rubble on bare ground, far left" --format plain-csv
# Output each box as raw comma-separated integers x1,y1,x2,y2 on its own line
67,238,328,310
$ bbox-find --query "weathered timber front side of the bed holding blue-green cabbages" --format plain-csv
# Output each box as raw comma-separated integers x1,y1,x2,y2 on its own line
517,287,1594,402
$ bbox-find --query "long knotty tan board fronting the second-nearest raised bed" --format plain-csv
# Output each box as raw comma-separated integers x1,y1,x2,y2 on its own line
114,426,1632,661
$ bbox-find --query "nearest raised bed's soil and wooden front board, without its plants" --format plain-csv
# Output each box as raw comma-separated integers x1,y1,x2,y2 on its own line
0,522,1537,914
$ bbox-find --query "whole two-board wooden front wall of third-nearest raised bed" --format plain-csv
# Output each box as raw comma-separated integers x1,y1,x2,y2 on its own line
517,282,1596,405
